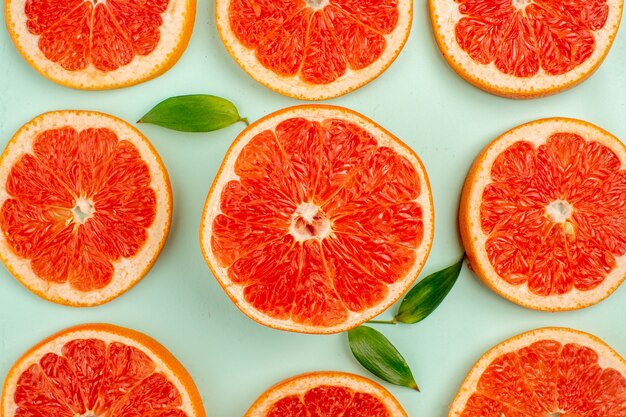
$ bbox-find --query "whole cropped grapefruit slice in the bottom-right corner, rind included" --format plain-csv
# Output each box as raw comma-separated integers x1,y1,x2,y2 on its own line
449,327,626,417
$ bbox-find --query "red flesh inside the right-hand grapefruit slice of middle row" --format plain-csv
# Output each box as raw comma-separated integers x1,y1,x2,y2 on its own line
480,133,626,295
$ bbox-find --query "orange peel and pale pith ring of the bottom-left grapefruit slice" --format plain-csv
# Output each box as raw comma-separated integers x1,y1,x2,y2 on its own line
0,323,206,417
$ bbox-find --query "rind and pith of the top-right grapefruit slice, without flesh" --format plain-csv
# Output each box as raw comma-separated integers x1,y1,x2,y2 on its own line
429,0,624,99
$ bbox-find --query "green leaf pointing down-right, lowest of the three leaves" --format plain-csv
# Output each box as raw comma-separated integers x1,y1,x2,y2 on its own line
348,326,419,391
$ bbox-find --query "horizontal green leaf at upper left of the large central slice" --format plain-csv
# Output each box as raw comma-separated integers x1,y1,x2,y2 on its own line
137,94,248,132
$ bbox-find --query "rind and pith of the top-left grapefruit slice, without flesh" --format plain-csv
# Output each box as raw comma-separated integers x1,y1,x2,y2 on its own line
4,0,196,90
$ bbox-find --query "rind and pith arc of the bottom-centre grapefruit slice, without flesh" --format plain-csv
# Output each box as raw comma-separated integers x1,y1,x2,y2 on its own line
244,371,407,417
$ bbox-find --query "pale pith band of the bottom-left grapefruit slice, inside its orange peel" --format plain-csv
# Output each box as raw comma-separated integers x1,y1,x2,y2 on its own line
0,330,203,417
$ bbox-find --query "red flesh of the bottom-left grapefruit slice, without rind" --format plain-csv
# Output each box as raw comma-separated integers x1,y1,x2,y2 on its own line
14,338,187,417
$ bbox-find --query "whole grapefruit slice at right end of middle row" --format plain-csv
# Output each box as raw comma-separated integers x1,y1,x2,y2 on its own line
459,118,626,311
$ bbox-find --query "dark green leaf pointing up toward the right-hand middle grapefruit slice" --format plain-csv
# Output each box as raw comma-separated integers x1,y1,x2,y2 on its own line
393,255,465,324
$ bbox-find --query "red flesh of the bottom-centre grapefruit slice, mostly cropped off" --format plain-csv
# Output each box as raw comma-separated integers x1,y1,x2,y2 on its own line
266,385,391,417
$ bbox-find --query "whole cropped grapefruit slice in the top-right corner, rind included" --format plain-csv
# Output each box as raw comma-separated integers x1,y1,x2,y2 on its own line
429,0,624,98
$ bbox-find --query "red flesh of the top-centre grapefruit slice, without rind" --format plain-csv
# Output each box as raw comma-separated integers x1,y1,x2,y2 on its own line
229,0,398,84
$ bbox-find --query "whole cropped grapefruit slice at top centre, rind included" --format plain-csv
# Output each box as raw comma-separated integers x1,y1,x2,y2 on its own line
216,0,413,100
